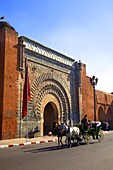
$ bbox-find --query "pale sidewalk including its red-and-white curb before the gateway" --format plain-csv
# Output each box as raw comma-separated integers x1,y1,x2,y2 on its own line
0,136,57,149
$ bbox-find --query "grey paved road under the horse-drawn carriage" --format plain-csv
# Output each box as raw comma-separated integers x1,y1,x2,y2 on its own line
0,134,113,170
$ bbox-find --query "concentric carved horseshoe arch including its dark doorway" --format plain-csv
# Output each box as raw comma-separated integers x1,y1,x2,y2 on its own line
30,72,72,136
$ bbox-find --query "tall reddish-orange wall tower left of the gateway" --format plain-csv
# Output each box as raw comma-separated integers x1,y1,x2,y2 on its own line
0,23,18,139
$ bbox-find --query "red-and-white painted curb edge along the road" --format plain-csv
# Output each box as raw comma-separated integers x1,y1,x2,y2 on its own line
0,139,57,149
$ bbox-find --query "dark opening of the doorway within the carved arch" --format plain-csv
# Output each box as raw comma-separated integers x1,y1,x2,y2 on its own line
43,102,58,135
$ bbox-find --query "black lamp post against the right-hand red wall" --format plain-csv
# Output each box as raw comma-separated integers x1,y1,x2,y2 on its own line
91,76,98,121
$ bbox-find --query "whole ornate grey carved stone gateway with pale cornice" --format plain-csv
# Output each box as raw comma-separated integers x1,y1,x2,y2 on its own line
19,37,76,135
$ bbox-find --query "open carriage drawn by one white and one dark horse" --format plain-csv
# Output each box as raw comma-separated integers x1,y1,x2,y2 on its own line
55,122,104,145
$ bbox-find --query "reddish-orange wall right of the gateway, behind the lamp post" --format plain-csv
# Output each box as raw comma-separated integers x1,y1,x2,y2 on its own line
81,64,113,129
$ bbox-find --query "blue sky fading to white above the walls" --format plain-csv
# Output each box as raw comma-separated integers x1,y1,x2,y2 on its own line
0,0,113,92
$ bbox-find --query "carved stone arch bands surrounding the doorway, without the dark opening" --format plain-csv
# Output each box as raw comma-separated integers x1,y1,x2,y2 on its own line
28,73,71,135
